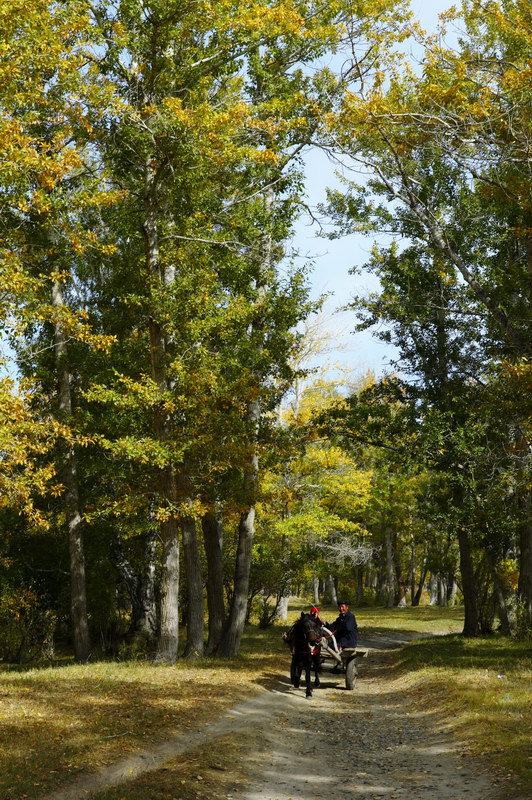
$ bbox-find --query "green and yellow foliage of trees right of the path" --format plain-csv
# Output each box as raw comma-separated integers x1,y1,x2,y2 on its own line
318,0,532,632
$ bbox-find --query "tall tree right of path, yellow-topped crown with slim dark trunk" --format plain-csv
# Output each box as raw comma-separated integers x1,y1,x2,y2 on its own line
320,2,530,635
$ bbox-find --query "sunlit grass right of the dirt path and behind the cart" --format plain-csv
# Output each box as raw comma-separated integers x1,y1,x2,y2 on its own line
280,603,532,796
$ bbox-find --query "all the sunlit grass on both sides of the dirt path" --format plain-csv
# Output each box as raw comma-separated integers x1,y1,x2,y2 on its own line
0,604,532,800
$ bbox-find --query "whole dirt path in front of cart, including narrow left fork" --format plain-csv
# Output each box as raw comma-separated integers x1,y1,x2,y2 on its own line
42,636,518,800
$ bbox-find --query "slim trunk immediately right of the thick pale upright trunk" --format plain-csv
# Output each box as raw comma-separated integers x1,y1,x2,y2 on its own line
181,517,204,658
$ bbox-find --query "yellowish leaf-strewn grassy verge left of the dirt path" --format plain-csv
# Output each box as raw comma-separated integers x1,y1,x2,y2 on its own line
0,648,286,800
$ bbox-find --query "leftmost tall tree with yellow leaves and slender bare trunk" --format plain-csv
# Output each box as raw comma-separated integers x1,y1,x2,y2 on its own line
0,0,121,661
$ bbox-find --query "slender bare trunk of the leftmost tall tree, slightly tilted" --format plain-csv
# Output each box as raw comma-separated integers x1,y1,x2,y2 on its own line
52,283,91,662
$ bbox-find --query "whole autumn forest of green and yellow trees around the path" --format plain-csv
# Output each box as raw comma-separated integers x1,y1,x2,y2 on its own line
0,0,532,663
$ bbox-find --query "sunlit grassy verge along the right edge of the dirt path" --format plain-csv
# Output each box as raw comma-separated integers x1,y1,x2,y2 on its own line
388,635,532,796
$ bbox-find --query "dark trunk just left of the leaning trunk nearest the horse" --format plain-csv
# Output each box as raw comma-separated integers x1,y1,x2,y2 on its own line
201,511,225,655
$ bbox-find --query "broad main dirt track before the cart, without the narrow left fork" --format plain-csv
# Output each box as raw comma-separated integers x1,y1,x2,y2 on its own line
241,639,502,800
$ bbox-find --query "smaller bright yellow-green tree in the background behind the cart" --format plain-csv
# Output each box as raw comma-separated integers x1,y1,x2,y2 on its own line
252,380,372,621
